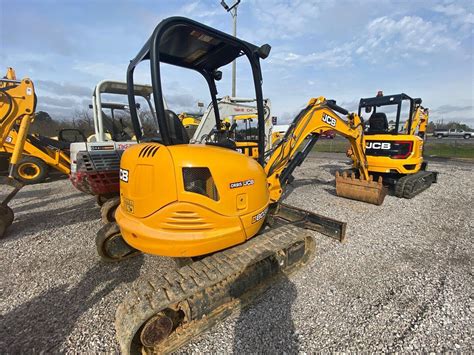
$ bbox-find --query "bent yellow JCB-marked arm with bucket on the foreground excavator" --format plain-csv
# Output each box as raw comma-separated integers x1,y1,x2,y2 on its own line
265,97,385,204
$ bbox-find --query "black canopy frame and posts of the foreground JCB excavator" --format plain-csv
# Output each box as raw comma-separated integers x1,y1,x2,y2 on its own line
127,17,271,166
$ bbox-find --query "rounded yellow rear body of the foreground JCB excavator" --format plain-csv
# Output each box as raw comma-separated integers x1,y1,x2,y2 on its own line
115,143,269,257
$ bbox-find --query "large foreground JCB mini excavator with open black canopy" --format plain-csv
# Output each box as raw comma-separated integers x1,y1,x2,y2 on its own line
97,17,381,354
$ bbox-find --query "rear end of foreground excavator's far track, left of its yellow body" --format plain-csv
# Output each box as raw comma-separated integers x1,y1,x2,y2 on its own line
95,222,141,262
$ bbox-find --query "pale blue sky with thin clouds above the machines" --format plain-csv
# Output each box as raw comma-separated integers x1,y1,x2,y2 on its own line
0,0,474,126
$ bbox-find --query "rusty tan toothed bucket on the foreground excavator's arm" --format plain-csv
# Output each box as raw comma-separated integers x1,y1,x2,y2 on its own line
336,172,387,205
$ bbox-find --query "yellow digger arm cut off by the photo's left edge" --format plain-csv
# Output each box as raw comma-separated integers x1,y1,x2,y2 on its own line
0,68,36,238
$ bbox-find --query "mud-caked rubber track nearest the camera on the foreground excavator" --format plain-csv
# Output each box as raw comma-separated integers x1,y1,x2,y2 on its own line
115,225,314,354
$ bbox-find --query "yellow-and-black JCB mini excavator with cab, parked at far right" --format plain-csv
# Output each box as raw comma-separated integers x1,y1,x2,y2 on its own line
342,92,438,199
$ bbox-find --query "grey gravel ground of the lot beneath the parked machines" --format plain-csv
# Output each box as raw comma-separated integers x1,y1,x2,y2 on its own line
0,155,474,353
